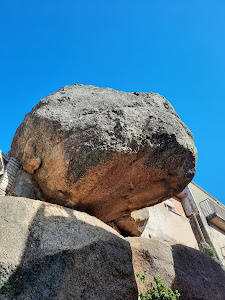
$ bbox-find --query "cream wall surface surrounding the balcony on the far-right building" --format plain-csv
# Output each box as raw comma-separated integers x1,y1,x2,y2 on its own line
188,182,225,265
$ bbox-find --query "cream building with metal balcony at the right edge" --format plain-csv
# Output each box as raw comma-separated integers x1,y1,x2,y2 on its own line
179,182,225,265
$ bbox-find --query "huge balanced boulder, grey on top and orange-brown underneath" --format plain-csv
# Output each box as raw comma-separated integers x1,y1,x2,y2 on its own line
11,85,196,222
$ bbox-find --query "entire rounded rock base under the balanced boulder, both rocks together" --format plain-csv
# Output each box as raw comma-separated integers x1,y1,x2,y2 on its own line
0,197,225,300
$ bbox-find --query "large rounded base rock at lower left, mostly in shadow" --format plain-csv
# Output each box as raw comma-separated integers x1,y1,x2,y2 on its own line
0,197,138,300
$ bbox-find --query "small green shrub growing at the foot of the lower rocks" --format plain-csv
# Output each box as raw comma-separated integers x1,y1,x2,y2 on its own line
136,273,180,300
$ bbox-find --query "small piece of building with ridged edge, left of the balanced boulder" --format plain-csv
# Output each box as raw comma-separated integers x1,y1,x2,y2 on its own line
0,150,20,196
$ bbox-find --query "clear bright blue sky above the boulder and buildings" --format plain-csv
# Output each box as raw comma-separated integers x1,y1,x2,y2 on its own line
0,0,225,203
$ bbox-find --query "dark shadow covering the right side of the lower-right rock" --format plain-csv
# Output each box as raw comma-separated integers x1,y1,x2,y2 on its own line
172,244,225,300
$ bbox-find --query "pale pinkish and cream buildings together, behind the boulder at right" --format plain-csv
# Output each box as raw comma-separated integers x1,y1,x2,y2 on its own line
131,182,225,266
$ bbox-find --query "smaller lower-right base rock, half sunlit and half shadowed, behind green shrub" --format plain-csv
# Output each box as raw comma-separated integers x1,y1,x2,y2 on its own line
127,237,225,300
